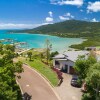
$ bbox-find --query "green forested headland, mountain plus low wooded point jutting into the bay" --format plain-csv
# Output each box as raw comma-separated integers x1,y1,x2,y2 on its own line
10,20,100,50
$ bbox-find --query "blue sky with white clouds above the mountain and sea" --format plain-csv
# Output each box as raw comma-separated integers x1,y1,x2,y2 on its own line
0,0,100,29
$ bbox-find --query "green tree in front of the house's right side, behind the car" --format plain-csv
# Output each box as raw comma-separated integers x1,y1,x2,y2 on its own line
74,55,97,81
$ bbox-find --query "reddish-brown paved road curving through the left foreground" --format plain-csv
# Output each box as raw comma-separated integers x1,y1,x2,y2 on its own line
17,65,58,100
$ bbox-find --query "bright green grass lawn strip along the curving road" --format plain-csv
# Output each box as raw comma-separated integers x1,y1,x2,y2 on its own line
18,57,58,86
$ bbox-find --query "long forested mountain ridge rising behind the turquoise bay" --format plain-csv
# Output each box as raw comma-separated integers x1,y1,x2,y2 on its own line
15,20,100,37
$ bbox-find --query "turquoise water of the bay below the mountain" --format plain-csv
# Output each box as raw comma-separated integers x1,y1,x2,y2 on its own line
0,30,83,52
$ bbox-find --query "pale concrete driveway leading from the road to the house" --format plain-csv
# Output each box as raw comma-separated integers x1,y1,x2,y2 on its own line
55,73,82,100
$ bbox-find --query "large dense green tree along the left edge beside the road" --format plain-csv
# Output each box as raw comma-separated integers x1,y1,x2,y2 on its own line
0,45,23,100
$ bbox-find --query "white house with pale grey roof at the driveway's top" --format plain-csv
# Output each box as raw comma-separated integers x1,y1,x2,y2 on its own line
53,51,89,74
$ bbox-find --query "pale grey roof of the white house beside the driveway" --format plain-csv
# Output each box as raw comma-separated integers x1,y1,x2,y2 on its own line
54,51,89,62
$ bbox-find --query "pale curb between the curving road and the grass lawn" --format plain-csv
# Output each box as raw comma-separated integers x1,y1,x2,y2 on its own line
23,64,61,100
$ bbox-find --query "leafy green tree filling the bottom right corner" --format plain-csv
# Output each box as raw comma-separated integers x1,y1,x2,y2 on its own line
83,62,100,100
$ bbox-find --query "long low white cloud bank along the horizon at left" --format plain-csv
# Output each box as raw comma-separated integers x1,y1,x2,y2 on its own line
0,23,49,29
